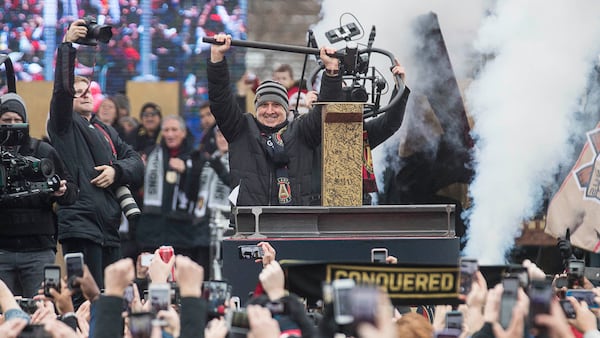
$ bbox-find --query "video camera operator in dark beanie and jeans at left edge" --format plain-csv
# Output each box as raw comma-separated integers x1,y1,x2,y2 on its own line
0,93,79,297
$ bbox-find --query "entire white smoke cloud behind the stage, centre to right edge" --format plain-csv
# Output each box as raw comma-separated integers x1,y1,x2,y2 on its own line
313,0,600,264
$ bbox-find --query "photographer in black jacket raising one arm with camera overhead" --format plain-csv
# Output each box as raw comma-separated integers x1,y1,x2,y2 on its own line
47,19,144,298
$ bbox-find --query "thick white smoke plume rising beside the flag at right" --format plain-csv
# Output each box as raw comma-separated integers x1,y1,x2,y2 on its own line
465,0,600,264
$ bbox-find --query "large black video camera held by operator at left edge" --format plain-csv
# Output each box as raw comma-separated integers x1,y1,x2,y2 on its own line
0,123,60,201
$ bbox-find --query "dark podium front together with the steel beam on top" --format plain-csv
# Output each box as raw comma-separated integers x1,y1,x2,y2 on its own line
223,204,460,301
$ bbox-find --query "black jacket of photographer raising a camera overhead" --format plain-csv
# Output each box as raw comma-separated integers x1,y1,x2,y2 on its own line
47,43,144,246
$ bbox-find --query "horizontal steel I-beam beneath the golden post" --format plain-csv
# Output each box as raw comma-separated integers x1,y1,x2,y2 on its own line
233,204,456,238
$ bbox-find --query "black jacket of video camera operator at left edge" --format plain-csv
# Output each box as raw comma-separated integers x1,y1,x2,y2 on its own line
0,138,79,252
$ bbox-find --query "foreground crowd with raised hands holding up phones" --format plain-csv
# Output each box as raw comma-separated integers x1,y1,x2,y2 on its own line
0,242,600,338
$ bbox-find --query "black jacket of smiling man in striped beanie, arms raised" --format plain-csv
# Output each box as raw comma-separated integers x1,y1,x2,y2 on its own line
207,60,342,206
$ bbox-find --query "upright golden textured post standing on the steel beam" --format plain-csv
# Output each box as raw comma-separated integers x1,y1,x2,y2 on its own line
321,103,363,207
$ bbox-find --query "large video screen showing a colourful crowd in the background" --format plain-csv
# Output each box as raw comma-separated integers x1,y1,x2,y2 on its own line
0,0,246,112
